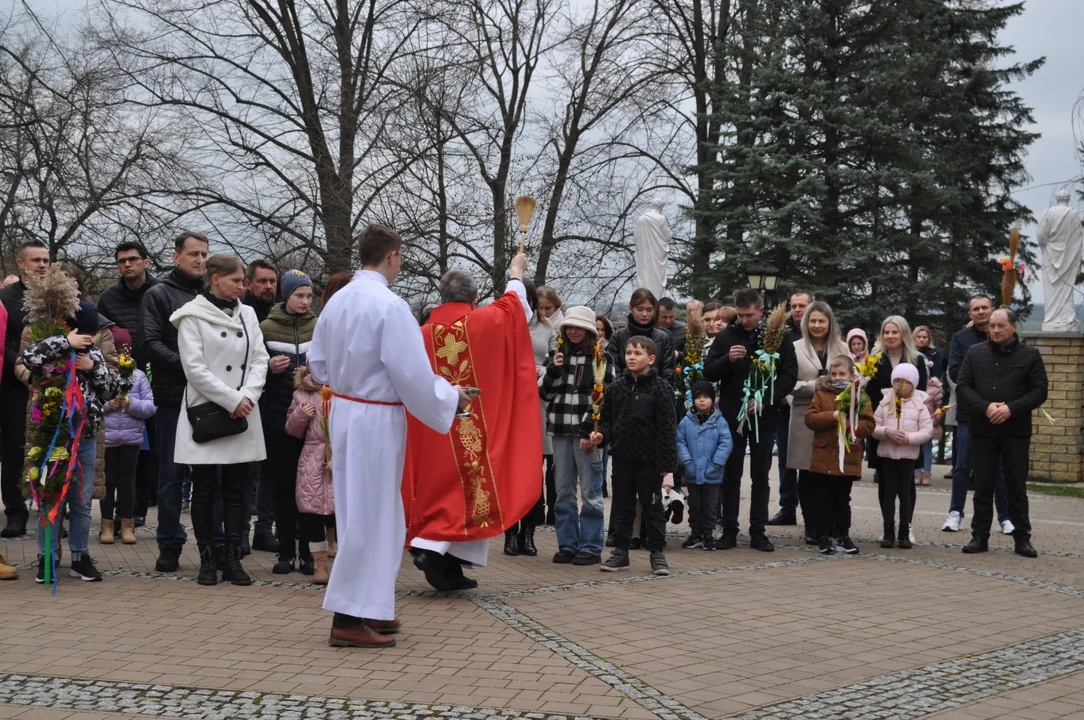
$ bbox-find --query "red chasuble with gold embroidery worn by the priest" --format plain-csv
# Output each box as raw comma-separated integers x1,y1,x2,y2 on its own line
402,292,542,543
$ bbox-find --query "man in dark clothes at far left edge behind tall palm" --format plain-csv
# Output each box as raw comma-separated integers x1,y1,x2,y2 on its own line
0,240,49,538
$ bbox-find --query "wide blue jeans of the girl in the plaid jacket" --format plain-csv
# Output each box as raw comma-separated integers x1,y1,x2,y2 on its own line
553,435,605,555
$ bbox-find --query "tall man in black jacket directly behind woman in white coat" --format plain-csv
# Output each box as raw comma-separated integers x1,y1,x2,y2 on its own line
136,232,208,573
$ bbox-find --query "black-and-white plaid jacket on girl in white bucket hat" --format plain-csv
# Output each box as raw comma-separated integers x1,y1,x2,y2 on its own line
539,350,614,438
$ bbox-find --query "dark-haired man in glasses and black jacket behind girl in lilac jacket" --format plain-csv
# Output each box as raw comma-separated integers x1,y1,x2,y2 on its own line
98,240,158,527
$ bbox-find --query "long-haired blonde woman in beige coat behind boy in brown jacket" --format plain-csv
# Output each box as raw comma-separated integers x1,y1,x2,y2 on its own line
787,301,851,545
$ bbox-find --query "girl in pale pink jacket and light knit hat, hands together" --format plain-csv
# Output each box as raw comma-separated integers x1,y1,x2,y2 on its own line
874,362,933,550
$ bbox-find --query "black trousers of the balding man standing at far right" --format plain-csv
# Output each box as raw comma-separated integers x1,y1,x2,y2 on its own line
971,435,1031,540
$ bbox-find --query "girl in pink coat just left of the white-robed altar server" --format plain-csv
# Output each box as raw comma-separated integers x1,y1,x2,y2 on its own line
286,365,335,584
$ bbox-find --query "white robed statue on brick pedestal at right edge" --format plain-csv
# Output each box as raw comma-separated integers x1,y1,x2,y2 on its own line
1035,190,1084,332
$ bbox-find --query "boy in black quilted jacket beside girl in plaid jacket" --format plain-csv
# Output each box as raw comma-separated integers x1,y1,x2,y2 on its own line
591,335,678,575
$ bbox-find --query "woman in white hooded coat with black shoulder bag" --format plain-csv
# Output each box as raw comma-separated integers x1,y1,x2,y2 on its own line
169,255,268,586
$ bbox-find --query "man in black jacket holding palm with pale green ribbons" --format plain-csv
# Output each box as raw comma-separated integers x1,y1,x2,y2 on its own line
704,288,798,552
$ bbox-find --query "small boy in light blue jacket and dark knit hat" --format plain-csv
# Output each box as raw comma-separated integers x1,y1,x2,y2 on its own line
678,380,734,550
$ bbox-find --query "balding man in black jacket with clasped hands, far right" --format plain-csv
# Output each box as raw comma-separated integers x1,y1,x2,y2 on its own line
956,308,1047,557
